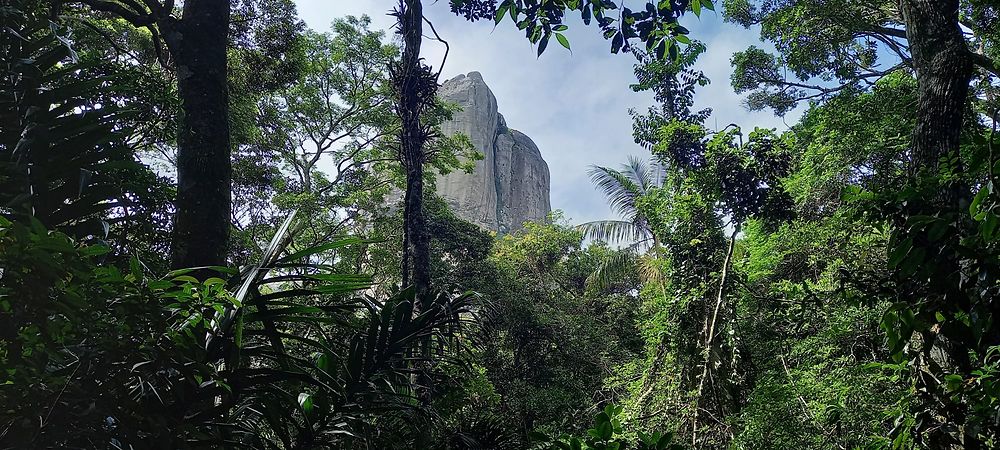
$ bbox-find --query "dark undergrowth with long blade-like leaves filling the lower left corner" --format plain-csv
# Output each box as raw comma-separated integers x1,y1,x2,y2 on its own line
2,213,478,448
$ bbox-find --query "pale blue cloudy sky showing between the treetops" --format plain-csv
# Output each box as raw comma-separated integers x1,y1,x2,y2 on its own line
296,0,795,223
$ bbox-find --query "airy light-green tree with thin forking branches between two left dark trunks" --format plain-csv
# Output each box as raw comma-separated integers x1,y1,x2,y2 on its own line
237,17,398,258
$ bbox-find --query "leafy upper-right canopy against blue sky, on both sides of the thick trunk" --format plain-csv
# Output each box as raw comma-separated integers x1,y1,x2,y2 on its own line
723,0,997,115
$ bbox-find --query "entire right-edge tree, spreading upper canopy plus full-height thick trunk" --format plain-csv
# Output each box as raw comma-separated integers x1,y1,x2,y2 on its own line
727,0,998,447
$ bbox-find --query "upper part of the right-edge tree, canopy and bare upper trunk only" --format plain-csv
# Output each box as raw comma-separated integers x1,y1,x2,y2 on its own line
725,0,1000,176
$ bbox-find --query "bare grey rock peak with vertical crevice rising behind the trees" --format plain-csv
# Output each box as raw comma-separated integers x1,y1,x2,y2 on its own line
437,72,551,234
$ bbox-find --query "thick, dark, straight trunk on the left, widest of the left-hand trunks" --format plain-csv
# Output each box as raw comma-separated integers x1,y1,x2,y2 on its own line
160,0,232,268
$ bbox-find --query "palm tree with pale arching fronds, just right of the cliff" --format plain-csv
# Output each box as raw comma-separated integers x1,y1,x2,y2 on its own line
579,156,662,289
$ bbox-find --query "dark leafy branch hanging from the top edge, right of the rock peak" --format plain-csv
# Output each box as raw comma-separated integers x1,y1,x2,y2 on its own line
451,0,715,60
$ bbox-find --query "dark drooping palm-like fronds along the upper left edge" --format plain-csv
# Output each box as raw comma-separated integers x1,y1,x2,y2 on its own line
0,3,143,237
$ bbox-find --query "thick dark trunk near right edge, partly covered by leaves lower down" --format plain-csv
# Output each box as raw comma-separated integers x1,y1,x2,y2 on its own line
898,0,976,449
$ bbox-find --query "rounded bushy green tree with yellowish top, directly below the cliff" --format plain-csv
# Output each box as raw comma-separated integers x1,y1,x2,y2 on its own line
477,223,638,439
